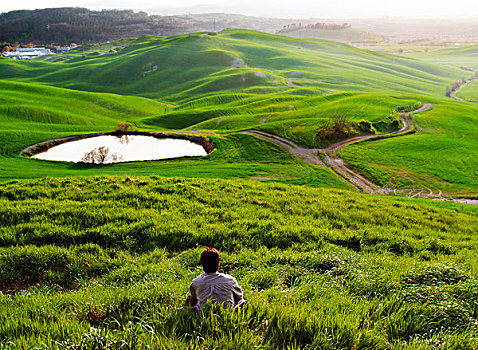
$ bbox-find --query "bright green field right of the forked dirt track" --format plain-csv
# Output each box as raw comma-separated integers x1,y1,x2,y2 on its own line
340,102,478,195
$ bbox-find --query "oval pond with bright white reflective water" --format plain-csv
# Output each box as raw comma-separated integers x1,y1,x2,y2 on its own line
32,135,207,164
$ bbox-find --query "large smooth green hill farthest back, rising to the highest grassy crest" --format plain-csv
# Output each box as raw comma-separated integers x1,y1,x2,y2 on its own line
0,29,462,100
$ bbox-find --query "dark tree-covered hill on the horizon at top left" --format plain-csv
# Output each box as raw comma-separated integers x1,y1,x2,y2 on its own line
0,7,193,45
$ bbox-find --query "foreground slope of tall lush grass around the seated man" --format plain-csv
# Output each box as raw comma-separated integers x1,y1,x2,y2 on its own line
0,176,478,349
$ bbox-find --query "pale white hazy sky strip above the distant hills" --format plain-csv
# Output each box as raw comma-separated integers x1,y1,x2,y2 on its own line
0,0,478,20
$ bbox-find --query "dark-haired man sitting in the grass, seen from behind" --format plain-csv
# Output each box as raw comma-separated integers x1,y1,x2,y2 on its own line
186,248,245,312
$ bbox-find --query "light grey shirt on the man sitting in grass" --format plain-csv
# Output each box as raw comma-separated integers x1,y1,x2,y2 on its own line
189,272,243,310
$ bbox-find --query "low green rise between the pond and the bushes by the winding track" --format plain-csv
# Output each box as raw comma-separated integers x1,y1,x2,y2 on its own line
151,89,417,148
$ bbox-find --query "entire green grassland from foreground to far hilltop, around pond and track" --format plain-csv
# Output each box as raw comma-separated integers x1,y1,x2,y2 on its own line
0,29,478,349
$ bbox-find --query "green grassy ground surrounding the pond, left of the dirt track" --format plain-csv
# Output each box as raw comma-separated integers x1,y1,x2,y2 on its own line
0,81,350,188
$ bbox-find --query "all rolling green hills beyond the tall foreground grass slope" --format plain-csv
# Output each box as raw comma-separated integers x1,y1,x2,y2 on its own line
0,29,477,194
